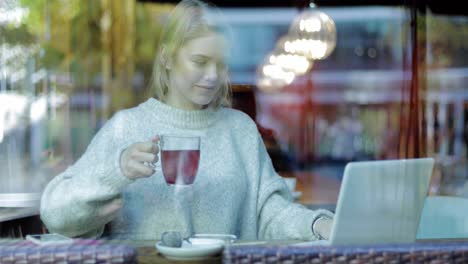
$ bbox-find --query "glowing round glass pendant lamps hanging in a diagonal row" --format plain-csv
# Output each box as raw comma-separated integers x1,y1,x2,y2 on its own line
257,3,336,92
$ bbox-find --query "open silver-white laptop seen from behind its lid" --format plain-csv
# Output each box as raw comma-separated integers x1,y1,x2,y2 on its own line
298,158,434,246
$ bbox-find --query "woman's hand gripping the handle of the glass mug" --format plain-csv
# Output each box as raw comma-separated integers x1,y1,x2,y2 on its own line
120,136,159,180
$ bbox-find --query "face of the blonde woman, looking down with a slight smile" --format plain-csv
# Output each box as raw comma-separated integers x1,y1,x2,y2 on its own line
166,33,226,110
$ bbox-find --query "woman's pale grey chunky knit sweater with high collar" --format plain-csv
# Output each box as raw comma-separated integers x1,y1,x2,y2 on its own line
40,99,327,240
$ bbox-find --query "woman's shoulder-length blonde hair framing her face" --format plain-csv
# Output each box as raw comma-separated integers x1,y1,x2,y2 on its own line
150,0,231,108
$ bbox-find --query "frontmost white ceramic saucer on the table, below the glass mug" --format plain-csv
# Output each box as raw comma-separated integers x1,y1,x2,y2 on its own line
156,238,224,261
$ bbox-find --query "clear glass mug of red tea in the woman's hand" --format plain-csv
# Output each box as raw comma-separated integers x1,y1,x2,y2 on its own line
159,135,200,185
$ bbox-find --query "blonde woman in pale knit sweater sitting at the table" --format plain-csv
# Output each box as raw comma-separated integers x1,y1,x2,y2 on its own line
41,0,332,240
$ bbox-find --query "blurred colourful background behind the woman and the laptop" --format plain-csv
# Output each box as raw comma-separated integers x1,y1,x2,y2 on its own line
0,0,468,230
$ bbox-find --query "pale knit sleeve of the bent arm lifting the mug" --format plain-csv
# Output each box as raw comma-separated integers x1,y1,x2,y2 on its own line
40,113,132,237
